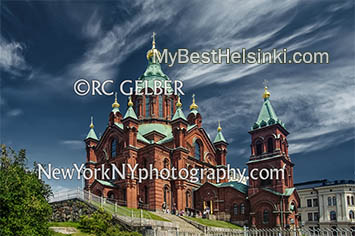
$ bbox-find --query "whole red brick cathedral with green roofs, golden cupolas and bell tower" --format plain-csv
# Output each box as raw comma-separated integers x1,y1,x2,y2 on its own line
85,39,299,228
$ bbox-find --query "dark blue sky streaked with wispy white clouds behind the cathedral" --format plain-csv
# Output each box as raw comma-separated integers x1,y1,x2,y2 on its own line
0,0,355,190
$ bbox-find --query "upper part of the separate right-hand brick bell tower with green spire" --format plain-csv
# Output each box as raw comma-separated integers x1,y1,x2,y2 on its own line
247,86,294,195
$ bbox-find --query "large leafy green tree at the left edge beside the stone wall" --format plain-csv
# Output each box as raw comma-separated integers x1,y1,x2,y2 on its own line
0,145,52,236
